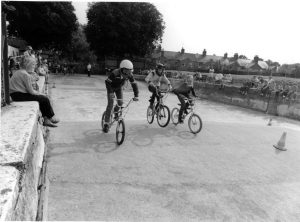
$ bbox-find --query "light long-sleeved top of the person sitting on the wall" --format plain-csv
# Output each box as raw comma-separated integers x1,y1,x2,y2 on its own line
9,69,39,95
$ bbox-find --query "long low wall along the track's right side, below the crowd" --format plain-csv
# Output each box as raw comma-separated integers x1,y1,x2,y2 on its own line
135,75,300,120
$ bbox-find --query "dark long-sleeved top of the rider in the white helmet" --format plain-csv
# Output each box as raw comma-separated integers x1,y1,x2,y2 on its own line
105,69,139,97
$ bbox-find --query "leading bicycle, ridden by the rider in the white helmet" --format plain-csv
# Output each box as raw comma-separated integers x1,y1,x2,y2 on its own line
101,98,133,145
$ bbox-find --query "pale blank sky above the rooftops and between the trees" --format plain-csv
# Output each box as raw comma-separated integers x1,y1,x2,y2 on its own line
72,0,300,64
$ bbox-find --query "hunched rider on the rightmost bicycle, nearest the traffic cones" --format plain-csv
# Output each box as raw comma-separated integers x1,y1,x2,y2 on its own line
173,75,197,123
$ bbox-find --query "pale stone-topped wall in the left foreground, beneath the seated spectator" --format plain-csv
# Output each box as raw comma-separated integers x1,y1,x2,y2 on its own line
0,77,47,221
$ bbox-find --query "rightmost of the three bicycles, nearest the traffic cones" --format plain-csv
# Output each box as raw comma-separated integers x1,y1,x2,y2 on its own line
171,98,203,134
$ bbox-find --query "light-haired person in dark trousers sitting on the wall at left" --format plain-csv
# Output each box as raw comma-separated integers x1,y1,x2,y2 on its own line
9,56,59,127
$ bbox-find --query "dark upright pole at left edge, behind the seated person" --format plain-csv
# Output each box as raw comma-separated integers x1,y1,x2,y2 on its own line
1,13,10,105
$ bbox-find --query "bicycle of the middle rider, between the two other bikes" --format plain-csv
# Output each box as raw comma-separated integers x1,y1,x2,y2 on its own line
147,88,170,127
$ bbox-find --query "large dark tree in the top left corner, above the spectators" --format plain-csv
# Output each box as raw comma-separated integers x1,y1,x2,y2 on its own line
7,1,77,49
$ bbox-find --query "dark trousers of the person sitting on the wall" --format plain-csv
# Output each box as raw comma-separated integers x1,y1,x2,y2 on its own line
10,92,54,119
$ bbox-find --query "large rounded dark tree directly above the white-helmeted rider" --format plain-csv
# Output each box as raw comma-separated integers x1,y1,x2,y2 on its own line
85,2,165,57
